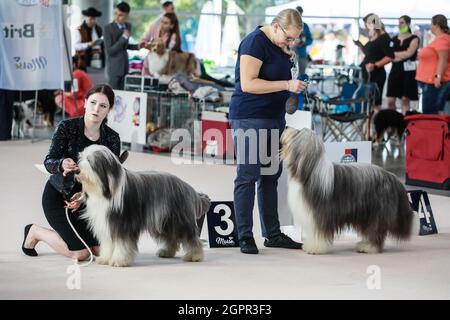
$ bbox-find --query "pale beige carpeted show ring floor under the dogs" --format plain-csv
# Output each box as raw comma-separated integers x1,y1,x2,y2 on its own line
0,141,450,299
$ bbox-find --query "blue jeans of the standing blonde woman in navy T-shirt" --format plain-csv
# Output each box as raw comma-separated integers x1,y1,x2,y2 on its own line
230,119,286,239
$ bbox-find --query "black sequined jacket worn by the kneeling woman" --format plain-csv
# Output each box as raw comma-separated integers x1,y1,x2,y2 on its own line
44,117,120,199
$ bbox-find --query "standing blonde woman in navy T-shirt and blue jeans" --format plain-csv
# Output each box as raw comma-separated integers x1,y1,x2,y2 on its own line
230,9,306,254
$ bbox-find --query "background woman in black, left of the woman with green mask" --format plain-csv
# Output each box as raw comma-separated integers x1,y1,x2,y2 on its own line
358,14,395,112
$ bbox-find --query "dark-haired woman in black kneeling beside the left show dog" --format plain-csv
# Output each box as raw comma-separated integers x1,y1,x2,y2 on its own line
22,85,120,261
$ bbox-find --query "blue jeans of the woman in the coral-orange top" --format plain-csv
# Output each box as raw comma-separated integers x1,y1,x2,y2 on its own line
419,81,450,114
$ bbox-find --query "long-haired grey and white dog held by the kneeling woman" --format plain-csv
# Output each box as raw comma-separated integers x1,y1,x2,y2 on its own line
75,145,210,267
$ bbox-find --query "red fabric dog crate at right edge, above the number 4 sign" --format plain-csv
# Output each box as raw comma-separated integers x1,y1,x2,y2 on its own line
405,114,450,189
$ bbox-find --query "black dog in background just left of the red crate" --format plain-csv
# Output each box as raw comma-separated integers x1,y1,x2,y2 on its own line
373,109,419,146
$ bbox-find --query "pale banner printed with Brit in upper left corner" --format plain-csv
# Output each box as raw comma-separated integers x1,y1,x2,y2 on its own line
0,0,66,90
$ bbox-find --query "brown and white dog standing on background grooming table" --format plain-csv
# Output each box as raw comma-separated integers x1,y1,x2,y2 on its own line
145,41,199,77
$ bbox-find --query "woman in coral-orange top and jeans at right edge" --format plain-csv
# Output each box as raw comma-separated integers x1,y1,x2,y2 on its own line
416,14,450,113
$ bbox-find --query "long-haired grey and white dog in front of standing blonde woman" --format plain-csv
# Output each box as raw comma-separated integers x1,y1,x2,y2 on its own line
281,128,419,254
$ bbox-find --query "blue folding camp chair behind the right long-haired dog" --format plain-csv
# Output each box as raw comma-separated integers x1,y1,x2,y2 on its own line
317,82,373,141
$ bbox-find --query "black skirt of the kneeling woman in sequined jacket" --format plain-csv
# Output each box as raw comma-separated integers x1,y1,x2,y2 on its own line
42,182,98,251
